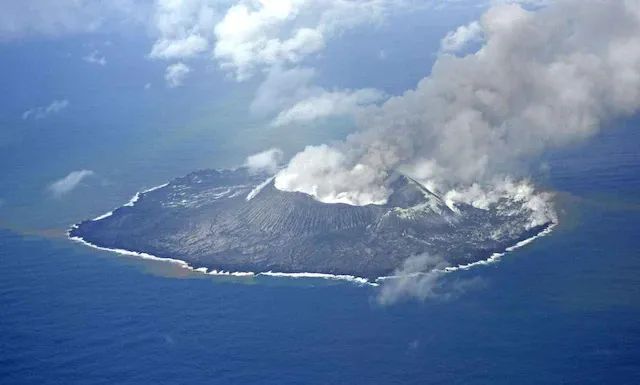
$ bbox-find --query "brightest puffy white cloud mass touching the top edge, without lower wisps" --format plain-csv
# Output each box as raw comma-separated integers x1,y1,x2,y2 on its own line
214,0,400,80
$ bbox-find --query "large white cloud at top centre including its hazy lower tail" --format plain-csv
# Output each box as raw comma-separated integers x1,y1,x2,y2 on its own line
213,0,406,126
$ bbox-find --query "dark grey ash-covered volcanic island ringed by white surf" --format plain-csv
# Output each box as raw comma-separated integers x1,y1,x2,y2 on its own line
70,169,546,278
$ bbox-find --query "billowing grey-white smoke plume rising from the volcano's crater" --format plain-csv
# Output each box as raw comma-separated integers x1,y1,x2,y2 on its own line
276,0,640,205
